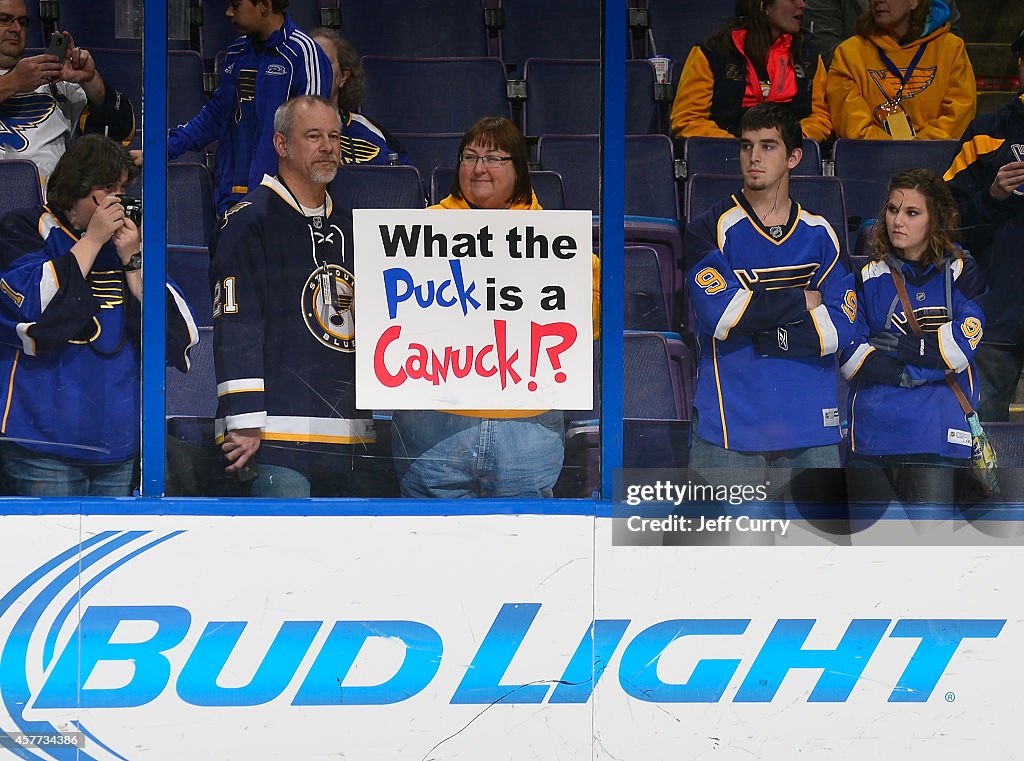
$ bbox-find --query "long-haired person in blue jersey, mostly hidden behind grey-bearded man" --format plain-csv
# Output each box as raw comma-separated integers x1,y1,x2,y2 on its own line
309,27,409,164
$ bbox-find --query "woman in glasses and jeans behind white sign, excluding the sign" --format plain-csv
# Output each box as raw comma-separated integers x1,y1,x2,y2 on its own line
392,117,597,499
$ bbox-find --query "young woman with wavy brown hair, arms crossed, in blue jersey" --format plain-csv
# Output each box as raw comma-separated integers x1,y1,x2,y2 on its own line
843,169,985,502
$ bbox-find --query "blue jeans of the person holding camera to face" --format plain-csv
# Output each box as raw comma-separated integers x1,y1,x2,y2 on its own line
0,441,135,497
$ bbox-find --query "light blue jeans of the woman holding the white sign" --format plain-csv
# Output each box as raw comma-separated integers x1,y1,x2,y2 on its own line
391,410,564,499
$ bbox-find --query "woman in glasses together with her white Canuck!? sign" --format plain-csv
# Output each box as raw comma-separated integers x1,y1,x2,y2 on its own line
355,118,597,499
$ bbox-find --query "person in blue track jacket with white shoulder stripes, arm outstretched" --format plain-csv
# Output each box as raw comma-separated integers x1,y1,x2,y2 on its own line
167,0,332,214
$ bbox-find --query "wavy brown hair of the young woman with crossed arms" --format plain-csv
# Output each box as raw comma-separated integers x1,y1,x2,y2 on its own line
870,168,964,266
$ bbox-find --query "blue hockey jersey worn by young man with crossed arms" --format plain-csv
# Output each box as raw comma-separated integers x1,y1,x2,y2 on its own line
685,194,857,452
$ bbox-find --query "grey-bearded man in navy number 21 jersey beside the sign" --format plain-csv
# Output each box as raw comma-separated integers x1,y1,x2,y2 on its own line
211,95,374,498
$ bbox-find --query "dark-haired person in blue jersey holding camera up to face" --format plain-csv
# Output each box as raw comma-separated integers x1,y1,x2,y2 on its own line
0,135,198,497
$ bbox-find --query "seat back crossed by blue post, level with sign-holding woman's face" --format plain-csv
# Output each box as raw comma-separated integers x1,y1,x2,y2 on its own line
538,135,679,219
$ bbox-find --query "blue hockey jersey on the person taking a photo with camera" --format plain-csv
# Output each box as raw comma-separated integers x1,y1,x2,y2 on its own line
0,207,199,463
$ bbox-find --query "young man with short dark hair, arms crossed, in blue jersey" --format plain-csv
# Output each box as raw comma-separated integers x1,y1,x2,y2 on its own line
685,103,857,471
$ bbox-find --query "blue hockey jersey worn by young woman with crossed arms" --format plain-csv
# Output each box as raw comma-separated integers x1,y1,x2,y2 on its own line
842,256,985,460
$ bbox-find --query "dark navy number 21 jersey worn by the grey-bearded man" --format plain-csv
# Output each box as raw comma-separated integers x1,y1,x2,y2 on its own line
211,176,375,472
